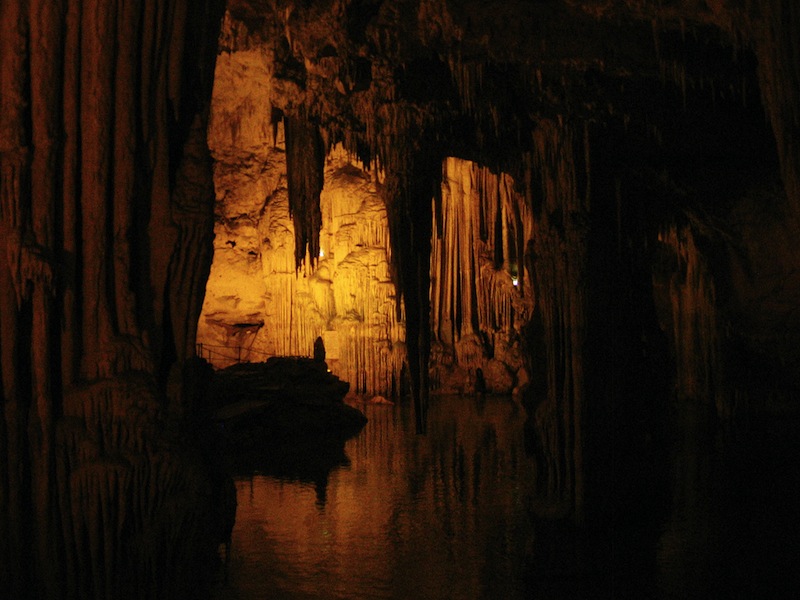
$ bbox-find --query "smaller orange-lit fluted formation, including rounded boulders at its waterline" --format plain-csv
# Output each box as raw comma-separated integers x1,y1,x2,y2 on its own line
431,158,534,393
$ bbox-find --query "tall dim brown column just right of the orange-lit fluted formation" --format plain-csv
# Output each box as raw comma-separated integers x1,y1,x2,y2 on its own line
526,121,589,519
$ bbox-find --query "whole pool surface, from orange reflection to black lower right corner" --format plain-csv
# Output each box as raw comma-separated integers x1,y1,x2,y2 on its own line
215,397,800,600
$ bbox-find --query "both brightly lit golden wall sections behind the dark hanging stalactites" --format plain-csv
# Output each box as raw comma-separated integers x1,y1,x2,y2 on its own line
197,89,533,395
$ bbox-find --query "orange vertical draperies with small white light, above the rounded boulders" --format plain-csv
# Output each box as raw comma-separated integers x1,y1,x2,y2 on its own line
431,157,533,368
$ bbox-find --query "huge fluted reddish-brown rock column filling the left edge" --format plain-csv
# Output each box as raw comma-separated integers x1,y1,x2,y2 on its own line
0,0,221,598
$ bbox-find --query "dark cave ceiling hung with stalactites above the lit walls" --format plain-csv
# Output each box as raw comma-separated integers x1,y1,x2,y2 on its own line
211,0,800,332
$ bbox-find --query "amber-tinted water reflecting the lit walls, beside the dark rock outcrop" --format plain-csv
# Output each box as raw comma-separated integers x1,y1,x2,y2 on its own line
217,397,535,599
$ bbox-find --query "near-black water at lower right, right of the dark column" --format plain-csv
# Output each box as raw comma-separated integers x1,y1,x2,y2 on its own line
654,407,800,598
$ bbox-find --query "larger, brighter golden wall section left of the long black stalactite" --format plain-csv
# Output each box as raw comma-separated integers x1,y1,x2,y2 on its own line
197,27,405,395
